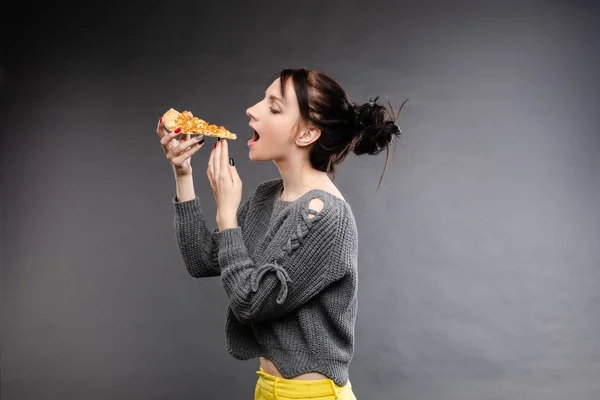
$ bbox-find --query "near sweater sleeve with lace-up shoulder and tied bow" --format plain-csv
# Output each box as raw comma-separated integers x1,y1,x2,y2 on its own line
215,206,357,325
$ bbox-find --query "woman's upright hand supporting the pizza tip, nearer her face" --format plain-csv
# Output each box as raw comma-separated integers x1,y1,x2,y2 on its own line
206,139,242,231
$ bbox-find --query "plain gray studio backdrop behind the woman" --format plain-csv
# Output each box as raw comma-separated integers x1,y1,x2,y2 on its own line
0,1,600,400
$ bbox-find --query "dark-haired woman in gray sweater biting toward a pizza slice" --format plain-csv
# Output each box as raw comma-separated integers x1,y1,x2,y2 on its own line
157,69,404,400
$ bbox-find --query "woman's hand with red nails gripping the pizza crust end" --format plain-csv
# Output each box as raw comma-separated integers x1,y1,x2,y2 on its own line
156,117,204,176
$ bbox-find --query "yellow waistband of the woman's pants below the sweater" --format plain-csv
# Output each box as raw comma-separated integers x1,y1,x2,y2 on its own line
256,366,352,398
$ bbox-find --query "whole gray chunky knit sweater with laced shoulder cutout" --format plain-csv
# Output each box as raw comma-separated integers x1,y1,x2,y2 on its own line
173,179,358,386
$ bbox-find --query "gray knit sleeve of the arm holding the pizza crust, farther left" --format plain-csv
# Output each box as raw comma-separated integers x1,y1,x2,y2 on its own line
173,196,250,278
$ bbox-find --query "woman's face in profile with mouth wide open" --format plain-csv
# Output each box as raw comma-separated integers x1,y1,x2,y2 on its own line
246,78,300,161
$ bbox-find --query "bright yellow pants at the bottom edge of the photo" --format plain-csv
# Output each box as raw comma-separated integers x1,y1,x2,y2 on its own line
254,367,356,400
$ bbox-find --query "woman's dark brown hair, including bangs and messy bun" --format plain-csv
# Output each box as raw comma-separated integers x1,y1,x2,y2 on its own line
274,68,408,188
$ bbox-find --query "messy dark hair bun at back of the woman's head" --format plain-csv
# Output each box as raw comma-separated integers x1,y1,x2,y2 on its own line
352,97,408,155
